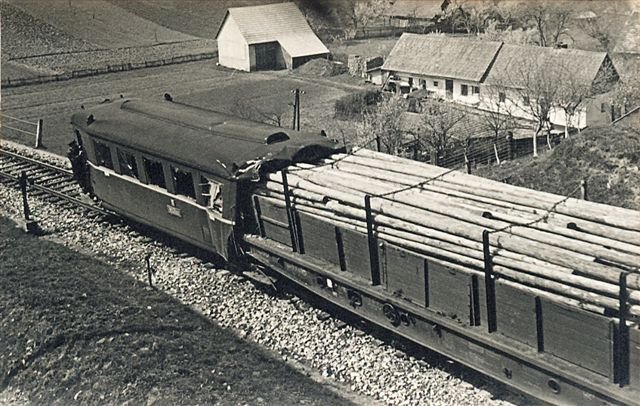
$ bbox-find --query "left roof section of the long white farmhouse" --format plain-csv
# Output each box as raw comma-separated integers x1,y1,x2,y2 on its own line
382,33,502,82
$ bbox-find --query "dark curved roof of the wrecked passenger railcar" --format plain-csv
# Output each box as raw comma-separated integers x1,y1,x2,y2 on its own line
71,100,341,180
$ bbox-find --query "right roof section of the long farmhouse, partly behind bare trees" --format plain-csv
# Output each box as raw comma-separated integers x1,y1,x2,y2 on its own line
485,44,607,87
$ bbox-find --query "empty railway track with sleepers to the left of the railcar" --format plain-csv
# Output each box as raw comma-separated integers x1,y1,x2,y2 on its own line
0,147,112,216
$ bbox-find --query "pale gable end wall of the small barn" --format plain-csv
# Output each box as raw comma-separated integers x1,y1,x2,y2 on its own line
218,15,255,72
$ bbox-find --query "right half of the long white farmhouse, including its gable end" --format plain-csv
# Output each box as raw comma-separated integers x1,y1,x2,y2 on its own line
488,44,618,129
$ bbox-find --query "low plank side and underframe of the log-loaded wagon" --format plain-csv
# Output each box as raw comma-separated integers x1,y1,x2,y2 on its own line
245,199,640,404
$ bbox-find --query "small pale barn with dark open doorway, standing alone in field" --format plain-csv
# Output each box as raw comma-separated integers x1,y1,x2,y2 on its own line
216,3,329,72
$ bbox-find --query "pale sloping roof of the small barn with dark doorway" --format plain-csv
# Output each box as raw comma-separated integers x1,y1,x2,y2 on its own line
216,2,329,57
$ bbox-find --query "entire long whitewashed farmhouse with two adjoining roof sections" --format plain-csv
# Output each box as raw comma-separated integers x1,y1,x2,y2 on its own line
382,34,618,128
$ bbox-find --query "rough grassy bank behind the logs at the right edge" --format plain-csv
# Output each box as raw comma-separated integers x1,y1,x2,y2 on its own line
475,126,640,210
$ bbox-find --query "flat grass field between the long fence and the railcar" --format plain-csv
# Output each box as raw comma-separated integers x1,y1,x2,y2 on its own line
1,61,361,154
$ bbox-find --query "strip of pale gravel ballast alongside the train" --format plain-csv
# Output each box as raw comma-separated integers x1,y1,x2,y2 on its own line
0,144,529,405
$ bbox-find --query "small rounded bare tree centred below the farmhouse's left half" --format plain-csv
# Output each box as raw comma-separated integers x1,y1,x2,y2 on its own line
416,99,469,159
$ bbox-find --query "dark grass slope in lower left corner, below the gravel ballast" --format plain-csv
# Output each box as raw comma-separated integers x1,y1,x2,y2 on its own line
0,217,349,404
